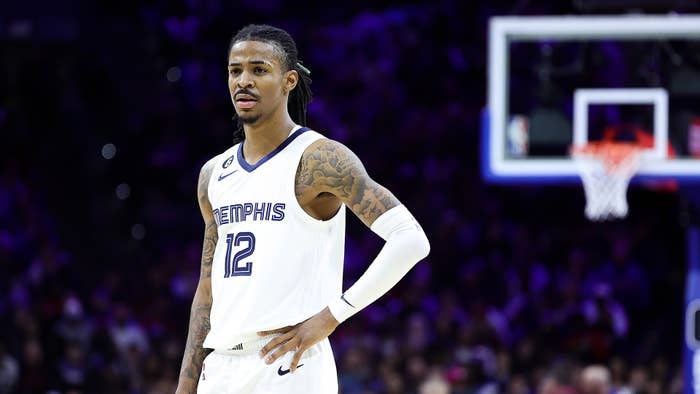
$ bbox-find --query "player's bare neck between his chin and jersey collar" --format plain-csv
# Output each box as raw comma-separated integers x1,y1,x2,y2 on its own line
243,113,295,164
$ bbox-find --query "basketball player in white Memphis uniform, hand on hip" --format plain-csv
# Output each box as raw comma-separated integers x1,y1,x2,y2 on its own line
177,25,429,394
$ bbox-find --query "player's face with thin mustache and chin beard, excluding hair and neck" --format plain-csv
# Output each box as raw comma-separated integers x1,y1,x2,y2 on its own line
228,41,298,124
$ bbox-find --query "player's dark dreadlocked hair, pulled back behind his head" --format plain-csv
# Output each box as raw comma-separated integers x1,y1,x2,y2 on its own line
228,25,313,145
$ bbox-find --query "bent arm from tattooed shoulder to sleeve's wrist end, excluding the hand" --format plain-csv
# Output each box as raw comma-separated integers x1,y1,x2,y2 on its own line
301,139,430,322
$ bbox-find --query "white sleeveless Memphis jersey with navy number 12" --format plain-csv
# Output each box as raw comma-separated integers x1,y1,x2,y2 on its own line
204,126,345,349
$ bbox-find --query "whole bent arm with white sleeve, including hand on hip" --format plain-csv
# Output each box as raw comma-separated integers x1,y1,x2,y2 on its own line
261,139,430,372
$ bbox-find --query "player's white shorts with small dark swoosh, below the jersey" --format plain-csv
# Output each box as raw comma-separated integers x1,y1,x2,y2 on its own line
197,338,338,394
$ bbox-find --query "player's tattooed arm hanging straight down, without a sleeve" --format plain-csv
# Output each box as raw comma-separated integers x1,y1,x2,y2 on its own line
177,160,219,394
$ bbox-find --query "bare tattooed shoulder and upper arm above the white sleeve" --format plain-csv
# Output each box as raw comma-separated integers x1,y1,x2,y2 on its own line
297,140,400,224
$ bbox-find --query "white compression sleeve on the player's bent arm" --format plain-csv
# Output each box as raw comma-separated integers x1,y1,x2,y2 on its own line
328,205,430,323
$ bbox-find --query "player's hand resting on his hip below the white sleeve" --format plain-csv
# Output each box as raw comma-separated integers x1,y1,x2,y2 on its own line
258,307,340,372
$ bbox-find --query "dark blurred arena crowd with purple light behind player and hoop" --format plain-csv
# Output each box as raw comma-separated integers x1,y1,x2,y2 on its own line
0,0,700,394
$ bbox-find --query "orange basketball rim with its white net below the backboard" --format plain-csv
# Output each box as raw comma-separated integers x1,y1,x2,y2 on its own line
571,141,642,221
